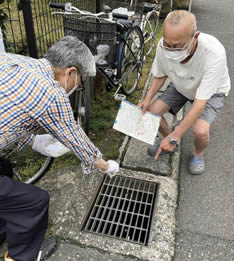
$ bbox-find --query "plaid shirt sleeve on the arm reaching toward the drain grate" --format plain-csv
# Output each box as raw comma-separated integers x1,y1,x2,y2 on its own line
35,92,102,174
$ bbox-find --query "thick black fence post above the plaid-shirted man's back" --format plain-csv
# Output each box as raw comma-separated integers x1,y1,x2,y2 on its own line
21,0,38,58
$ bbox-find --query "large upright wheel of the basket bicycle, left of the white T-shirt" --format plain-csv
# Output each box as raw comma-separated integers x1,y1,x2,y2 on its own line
118,26,144,95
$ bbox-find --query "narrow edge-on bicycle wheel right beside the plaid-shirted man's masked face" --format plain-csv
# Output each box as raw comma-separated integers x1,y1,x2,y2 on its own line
70,77,91,136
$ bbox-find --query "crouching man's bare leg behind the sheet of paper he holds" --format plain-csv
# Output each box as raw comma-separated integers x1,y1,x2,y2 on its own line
149,100,170,137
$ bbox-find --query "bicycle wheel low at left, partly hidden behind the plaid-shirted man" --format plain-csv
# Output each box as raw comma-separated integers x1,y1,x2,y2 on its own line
0,144,53,184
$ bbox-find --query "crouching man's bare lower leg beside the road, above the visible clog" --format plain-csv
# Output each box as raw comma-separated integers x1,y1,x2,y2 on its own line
192,119,210,156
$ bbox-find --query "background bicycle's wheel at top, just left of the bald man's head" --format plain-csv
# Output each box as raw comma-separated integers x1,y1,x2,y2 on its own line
143,11,159,57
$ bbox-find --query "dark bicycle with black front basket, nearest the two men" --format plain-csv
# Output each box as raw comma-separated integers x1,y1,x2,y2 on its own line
50,1,144,99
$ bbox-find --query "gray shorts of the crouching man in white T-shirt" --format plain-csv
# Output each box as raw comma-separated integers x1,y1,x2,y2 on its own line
158,84,225,124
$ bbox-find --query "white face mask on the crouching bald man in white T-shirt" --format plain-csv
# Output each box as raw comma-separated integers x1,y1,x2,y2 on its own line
160,34,195,63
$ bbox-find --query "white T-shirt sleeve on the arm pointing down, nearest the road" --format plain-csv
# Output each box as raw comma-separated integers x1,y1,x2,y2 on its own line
195,59,226,100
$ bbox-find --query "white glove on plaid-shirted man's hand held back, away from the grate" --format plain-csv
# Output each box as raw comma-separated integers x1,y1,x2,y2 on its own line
32,134,70,158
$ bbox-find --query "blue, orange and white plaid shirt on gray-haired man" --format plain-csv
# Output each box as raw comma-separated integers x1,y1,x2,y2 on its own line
0,53,102,174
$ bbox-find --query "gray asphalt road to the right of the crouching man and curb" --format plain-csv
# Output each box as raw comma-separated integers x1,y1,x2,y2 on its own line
174,0,234,261
